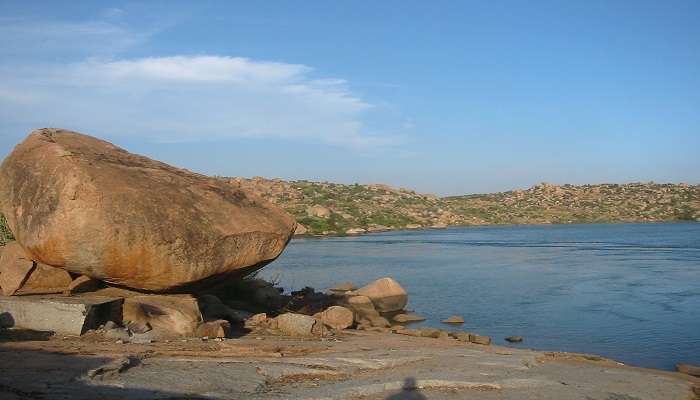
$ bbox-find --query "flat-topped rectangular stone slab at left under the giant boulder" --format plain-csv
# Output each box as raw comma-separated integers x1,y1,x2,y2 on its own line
0,295,124,335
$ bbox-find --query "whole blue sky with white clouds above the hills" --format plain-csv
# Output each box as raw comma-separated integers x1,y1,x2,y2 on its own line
0,0,700,195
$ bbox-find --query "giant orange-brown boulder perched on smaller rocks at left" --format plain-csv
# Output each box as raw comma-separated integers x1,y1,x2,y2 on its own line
0,129,295,291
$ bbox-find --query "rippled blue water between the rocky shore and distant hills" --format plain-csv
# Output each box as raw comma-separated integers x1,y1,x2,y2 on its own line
262,223,700,369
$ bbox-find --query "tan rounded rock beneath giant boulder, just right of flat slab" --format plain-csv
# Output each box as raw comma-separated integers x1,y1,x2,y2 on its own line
123,295,203,339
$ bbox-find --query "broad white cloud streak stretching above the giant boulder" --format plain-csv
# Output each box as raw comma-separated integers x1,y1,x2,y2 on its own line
0,55,396,147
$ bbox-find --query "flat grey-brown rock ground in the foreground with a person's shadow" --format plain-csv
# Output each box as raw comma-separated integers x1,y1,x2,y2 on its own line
0,331,700,400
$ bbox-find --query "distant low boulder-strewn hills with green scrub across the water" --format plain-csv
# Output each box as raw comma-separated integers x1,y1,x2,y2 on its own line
222,177,700,235
